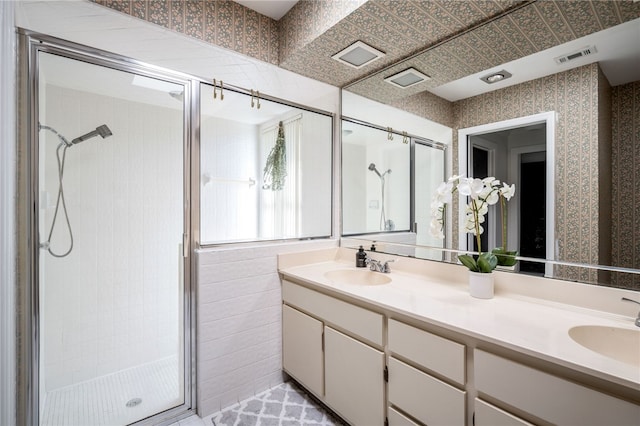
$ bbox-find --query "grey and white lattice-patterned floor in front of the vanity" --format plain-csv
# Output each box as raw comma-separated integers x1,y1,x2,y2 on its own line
205,382,345,426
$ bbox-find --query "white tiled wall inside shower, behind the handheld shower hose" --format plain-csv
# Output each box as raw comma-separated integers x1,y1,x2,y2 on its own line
40,86,183,390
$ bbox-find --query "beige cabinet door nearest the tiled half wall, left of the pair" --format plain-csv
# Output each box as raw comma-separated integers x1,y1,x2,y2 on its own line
282,305,324,397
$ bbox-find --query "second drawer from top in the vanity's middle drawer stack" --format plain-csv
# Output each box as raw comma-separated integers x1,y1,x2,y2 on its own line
388,357,466,426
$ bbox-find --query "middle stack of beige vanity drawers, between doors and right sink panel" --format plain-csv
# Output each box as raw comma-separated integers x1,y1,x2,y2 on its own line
388,319,466,426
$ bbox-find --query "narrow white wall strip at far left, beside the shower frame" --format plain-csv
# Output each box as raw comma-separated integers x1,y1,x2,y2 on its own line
0,2,17,425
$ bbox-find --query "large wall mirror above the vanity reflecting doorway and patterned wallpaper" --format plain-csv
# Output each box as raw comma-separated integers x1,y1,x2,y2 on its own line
343,2,640,290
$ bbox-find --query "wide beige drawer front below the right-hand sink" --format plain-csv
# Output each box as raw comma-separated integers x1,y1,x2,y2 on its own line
474,349,640,426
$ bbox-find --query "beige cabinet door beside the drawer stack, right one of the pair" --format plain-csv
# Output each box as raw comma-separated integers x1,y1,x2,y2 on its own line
324,327,385,426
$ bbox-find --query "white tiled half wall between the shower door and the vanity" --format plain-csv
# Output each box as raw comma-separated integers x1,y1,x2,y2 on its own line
197,240,338,417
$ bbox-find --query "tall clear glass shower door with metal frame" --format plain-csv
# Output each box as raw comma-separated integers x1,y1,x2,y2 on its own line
36,51,189,425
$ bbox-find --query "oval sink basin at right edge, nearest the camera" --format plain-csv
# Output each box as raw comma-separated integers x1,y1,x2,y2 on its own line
569,325,640,367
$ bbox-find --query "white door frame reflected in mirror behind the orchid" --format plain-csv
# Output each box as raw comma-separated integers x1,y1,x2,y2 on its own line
458,111,557,277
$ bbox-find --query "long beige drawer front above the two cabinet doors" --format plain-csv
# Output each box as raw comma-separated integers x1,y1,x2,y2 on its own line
282,280,384,347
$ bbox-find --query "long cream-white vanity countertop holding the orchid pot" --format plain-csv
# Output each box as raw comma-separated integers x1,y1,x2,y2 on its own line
279,248,640,391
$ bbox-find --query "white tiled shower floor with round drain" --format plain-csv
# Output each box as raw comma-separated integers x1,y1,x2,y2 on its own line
40,357,182,426
